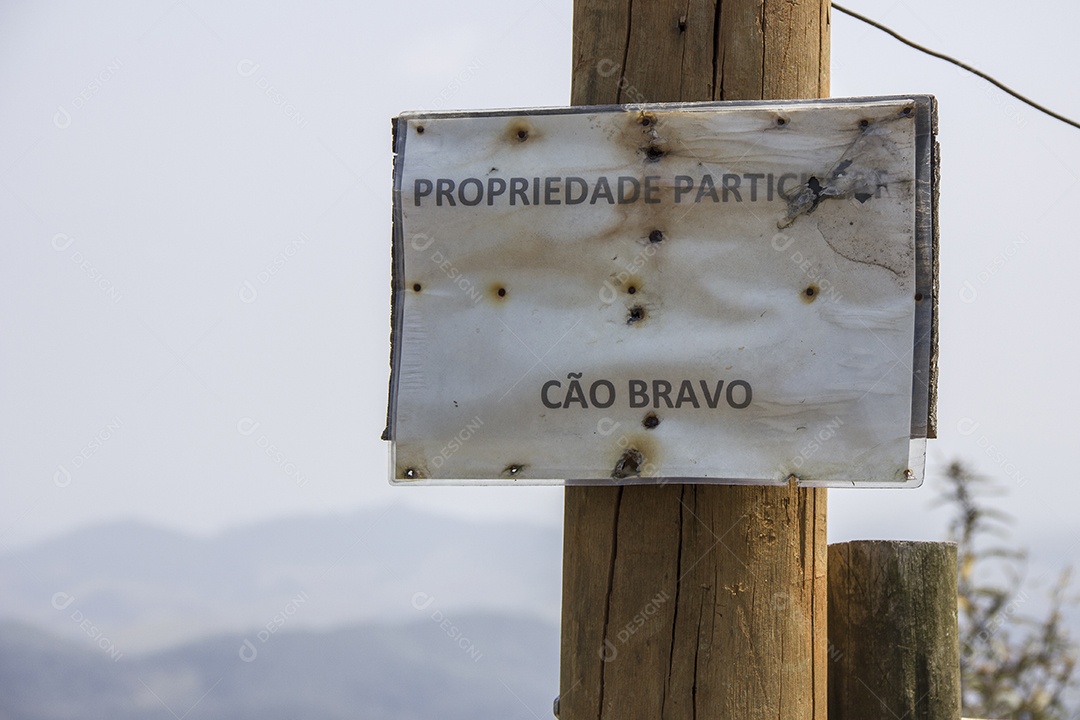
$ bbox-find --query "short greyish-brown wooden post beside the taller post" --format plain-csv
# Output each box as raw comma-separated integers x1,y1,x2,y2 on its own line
828,541,960,720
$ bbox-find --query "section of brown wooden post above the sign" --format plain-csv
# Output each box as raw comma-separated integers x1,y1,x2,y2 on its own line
570,0,829,105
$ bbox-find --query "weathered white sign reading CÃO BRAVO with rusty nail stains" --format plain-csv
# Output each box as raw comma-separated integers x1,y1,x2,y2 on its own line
387,96,935,487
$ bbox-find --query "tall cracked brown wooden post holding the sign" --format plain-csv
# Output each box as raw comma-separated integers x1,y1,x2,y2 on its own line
557,0,829,720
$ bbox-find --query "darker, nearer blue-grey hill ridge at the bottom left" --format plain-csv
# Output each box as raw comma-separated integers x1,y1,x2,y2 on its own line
0,613,558,720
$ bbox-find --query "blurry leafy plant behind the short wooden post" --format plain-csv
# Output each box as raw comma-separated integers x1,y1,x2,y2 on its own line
943,462,1078,720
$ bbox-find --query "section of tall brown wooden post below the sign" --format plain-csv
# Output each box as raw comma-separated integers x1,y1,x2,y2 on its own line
561,484,827,720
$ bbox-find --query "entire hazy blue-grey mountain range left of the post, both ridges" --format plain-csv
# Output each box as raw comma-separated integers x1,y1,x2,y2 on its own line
0,507,562,720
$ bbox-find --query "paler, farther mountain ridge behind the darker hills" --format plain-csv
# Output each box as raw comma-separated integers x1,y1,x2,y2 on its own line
0,507,562,655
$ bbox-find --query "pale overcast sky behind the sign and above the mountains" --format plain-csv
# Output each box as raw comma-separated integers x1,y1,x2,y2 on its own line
0,0,1080,591
